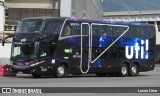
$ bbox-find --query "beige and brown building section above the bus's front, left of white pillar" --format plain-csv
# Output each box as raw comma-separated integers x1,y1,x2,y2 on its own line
4,0,60,31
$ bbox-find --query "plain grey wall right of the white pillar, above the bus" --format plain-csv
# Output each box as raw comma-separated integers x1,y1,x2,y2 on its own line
71,0,103,19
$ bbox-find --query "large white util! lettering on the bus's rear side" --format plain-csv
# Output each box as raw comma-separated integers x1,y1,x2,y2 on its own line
125,39,149,59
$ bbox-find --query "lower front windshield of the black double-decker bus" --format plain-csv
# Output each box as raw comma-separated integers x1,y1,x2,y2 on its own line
11,43,35,60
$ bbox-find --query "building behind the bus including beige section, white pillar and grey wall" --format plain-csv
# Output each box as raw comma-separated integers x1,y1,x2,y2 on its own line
4,0,103,31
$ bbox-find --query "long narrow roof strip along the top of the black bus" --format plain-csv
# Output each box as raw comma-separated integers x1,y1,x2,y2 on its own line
23,17,153,26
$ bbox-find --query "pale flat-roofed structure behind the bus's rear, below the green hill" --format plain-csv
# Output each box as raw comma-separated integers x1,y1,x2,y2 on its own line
104,10,160,45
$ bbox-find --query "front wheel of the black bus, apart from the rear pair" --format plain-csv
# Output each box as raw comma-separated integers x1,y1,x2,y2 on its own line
56,64,67,78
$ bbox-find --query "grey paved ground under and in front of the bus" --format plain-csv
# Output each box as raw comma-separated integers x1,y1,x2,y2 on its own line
0,67,160,96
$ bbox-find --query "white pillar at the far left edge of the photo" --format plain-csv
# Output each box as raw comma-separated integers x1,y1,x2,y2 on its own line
0,0,5,32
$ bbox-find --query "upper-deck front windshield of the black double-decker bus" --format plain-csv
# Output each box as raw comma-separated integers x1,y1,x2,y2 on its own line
16,19,43,33
